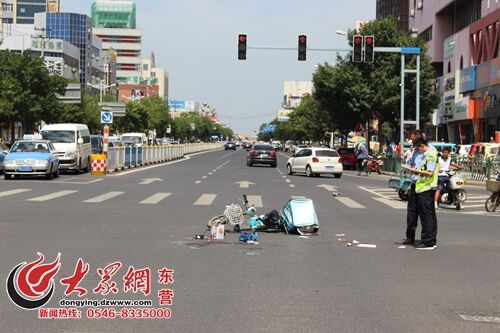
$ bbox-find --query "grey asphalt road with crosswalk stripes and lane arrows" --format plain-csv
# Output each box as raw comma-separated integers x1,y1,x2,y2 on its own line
0,150,500,332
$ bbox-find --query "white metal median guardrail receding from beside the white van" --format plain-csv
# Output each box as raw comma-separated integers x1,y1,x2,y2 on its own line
107,143,223,173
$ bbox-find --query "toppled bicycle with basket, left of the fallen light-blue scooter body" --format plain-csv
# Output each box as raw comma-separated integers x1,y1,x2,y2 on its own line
207,194,256,232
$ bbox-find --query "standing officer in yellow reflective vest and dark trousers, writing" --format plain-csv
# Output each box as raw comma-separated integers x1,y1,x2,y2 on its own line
409,137,439,250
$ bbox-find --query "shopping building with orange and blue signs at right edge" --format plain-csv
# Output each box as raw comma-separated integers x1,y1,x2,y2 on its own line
409,0,500,143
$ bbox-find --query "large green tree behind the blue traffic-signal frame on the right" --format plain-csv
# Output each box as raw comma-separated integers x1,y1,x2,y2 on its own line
313,18,439,141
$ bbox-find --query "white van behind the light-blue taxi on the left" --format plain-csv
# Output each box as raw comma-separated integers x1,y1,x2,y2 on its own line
40,124,92,173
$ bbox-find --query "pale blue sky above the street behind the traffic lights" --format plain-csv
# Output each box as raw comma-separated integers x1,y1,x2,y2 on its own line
61,0,376,134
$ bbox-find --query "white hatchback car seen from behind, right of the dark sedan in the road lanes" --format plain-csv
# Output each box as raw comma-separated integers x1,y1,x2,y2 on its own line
286,147,343,178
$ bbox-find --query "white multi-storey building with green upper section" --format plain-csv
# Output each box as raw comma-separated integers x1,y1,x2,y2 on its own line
91,0,142,83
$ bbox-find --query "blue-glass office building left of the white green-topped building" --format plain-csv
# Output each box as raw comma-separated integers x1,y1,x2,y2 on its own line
35,13,106,91
